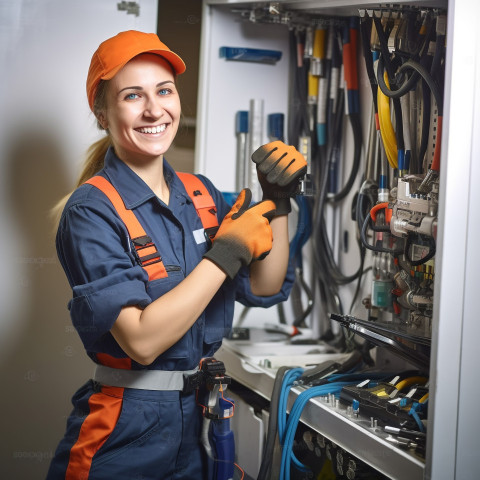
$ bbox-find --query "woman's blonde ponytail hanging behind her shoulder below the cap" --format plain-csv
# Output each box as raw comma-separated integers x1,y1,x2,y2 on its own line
50,80,112,229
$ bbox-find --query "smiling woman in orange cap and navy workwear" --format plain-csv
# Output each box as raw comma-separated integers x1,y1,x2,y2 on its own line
47,31,305,480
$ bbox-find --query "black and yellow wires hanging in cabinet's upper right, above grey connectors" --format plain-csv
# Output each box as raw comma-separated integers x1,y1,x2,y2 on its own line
370,9,446,190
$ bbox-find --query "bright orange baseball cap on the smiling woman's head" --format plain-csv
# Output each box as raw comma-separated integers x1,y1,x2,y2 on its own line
87,30,186,110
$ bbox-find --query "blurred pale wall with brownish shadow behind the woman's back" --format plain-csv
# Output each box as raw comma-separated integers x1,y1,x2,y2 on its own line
0,0,157,479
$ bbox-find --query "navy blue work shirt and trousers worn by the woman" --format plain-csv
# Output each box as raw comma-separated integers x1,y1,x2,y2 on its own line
47,149,293,480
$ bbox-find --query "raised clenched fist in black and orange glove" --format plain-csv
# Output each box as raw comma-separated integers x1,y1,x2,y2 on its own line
252,140,307,215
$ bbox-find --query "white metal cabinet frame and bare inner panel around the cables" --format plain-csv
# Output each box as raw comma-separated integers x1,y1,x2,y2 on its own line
196,0,480,480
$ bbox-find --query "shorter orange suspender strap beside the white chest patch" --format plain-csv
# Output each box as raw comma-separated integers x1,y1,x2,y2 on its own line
177,172,218,242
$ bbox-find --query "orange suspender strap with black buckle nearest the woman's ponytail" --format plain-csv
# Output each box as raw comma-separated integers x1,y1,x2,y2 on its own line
85,175,168,281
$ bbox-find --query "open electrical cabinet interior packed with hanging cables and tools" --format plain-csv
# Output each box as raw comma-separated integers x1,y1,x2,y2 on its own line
196,1,478,478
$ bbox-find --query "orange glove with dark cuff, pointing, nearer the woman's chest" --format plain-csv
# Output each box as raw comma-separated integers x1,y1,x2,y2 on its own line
203,188,275,278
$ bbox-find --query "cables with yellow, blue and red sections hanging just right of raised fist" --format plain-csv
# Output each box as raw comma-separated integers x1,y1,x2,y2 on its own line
288,17,364,338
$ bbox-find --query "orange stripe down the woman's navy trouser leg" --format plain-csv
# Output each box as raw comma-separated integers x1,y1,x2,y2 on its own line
65,387,123,480
